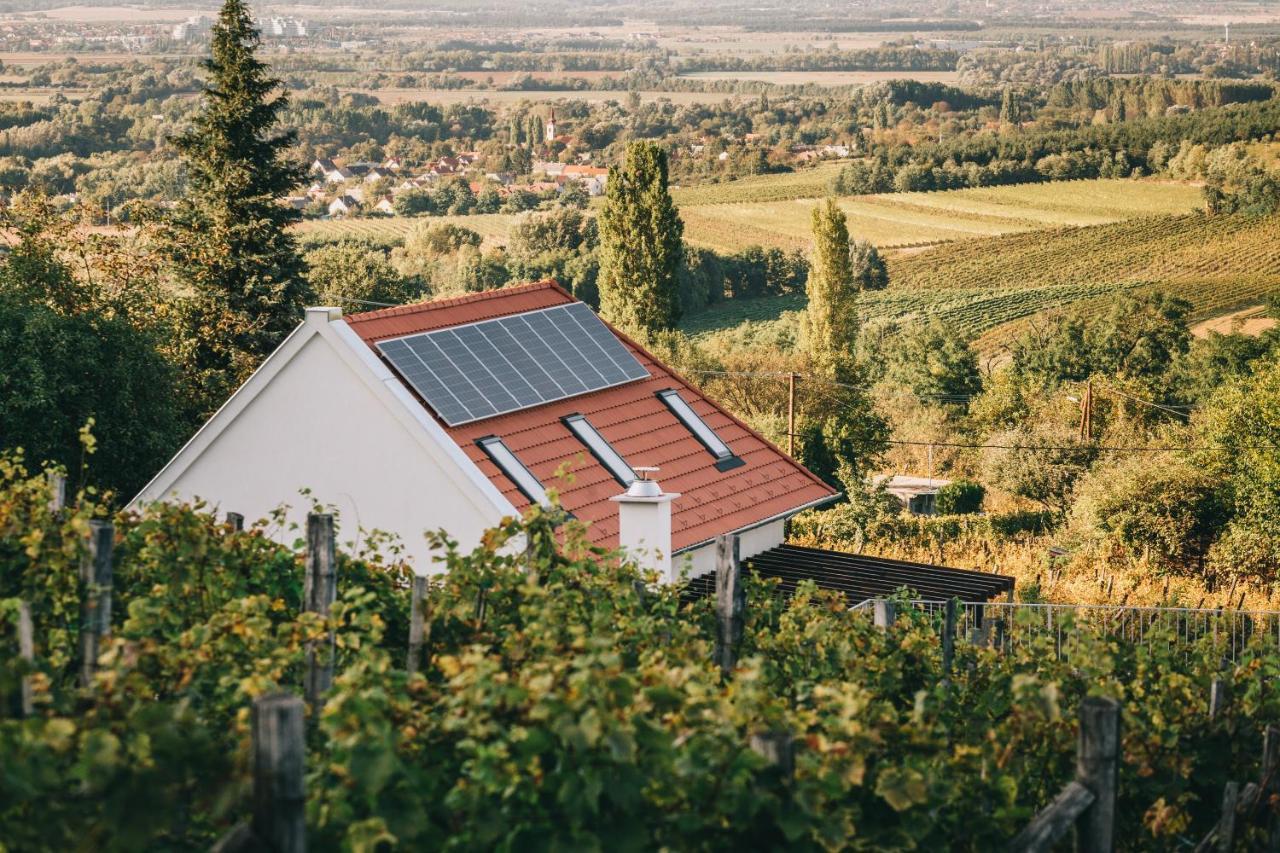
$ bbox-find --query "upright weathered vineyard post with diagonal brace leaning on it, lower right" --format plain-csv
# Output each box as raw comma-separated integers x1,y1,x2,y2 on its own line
1075,697,1120,853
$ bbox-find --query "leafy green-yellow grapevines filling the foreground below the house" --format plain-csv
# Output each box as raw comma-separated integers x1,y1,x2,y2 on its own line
0,457,1280,850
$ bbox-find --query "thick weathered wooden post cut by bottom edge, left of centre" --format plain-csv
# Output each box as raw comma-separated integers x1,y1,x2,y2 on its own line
253,693,307,853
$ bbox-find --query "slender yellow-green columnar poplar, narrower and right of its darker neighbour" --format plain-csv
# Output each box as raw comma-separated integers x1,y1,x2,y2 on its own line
804,199,859,382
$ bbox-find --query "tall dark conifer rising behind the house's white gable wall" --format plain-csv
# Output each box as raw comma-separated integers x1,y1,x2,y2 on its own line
165,0,306,415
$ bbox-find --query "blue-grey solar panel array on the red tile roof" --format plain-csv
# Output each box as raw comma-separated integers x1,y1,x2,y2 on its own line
378,302,649,427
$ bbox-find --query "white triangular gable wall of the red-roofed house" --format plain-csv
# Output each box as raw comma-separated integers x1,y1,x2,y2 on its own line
136,320,514,573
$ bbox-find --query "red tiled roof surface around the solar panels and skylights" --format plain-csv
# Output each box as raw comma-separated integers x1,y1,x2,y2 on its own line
347,282,836,551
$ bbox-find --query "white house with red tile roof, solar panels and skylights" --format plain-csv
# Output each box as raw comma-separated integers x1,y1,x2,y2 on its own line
134,282,836,575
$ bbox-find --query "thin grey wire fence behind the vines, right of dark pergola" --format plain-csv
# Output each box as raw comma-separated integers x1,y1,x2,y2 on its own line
851,599,1280,662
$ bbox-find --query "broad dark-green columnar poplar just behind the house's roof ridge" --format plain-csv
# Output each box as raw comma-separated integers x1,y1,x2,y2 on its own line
599,142,685,334
